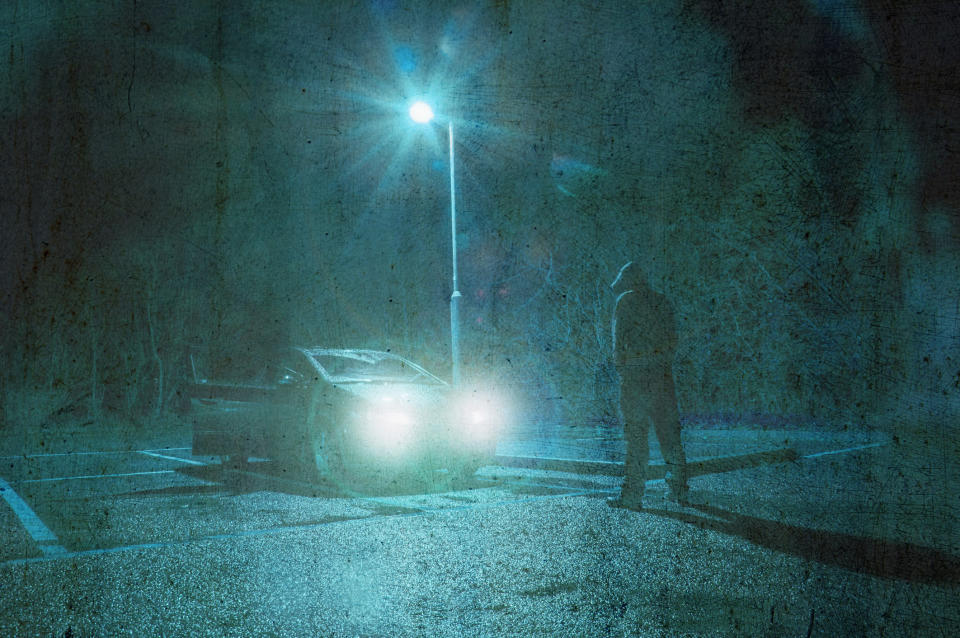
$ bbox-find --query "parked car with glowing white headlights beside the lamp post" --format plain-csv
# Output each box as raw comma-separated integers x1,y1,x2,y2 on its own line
189,347,506,482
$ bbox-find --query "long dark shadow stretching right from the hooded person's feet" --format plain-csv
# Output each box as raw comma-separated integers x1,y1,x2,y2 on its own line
644,505,960,584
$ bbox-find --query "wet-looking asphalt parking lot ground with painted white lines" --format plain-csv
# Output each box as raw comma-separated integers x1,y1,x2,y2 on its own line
0,425,960,637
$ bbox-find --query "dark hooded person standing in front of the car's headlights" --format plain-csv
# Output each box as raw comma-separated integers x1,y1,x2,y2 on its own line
609,262,689,510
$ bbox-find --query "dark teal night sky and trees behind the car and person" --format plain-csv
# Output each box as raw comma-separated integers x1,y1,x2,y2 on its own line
0,0,960,436
